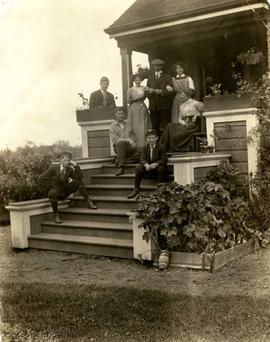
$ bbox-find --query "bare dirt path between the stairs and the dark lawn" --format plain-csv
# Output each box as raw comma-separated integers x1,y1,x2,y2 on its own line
0,227,270,296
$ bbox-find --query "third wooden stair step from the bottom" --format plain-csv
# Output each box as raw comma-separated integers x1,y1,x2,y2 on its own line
59,207,129,223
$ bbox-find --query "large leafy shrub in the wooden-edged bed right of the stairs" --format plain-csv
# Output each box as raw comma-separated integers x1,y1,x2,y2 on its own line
137,180,258,253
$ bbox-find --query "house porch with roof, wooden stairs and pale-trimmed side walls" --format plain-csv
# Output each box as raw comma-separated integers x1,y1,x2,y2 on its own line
8,0,270,258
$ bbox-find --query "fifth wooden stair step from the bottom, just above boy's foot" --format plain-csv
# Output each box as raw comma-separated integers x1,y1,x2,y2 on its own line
86,184,156,197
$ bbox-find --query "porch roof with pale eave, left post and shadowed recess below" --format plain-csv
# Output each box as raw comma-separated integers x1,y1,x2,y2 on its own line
105,0,270,103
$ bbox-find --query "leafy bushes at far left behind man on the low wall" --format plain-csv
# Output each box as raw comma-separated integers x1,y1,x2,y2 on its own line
0,140,80,214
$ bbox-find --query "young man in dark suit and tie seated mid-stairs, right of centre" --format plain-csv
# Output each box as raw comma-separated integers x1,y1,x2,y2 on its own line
127,129,168,198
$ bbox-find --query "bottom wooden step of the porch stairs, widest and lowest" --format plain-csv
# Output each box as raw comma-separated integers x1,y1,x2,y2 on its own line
28,233,133,258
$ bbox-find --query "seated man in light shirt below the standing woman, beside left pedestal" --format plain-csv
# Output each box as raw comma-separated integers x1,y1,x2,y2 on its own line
110,107,139,176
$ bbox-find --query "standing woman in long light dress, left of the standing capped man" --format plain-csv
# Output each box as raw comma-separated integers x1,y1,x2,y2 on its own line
127,75,149,148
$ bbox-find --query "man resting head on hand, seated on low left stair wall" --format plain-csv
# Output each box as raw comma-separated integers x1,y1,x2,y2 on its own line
39,152,97,223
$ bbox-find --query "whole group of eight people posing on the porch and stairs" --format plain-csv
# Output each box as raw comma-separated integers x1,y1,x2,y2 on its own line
40,59,203,223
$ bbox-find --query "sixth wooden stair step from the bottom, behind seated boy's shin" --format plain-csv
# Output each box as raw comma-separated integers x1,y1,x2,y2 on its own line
91,173,157,186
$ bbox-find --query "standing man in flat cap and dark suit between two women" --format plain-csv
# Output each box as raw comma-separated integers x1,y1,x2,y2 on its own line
146,59,173,135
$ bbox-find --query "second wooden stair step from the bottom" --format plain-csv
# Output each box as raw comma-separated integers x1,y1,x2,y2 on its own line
41,220,133,241
